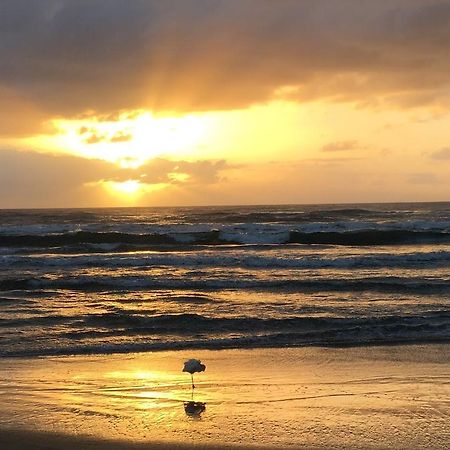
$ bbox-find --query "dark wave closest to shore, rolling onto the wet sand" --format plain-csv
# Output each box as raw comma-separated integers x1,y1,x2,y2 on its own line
0,313,450,356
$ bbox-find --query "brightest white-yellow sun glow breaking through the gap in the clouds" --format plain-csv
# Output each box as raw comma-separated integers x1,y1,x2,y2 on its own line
33,110,208,168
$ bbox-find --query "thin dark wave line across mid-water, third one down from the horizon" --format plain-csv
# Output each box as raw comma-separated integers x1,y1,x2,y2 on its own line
0,273,450,294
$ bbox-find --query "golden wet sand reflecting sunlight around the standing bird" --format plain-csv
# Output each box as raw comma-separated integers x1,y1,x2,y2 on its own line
0,344,450,450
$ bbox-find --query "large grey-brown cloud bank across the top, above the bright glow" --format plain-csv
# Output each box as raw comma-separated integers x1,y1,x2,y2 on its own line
0,0,450,134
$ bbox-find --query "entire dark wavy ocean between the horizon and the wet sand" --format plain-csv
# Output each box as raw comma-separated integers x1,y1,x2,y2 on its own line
0,203,450,357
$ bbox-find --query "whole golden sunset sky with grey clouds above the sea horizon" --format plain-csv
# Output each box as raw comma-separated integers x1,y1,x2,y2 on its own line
0,0,450,208
